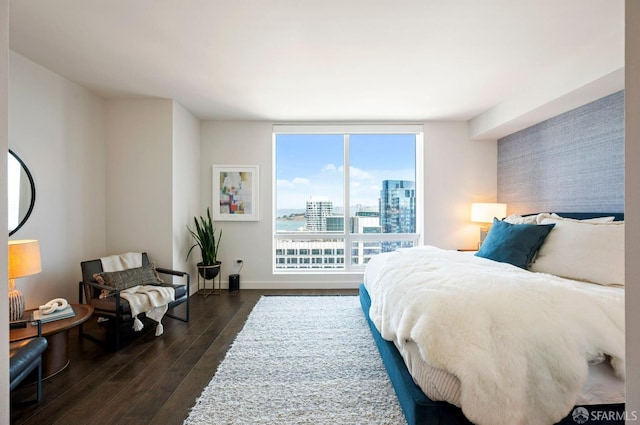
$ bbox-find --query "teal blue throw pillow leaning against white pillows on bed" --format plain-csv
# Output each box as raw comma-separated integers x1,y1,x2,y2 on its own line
475,218,555,269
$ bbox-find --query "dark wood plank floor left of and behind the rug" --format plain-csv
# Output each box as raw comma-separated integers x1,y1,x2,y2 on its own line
11,289,357,425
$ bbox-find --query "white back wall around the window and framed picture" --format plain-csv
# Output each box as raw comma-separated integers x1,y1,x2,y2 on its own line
200,121,497,288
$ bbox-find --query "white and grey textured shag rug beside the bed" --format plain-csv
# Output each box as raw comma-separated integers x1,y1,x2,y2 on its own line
184,296,406,425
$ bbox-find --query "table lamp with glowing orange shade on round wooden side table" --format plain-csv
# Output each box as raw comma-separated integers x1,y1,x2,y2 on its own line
8,240,42,320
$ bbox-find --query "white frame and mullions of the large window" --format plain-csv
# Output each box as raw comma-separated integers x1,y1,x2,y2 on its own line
271,124,425,275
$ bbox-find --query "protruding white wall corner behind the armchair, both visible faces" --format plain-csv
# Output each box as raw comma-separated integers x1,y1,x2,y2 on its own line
105,99,200,280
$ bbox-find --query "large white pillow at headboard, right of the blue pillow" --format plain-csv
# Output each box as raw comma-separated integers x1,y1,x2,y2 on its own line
529,218,624,286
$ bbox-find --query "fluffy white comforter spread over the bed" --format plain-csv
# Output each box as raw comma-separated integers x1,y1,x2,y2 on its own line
365,247,624,425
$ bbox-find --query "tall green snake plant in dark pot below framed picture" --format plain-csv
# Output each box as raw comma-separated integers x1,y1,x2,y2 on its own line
187,208,222,279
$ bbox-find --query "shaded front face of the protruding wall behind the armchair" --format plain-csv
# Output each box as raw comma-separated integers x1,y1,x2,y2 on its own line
105,99,174,266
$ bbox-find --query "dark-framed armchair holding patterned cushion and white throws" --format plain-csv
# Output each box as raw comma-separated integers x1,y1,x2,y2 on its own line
78,252,190,351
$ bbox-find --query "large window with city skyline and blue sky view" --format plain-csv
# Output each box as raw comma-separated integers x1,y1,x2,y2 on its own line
273,125,423,272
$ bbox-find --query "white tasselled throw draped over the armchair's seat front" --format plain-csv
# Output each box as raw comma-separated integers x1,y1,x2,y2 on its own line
120,285,175,336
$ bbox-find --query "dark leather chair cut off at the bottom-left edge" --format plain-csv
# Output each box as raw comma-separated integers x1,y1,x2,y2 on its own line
9,320,47,401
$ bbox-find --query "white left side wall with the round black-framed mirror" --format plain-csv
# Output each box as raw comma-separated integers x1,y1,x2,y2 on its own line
3,52,106,308
